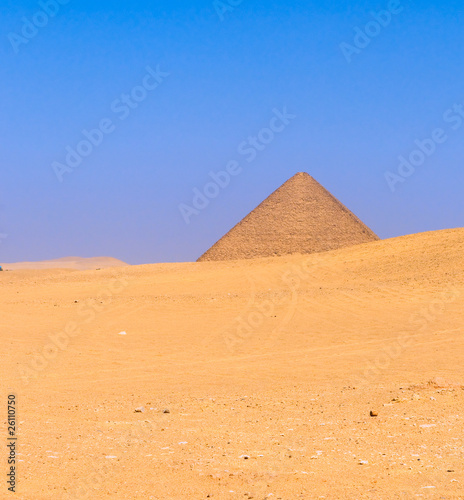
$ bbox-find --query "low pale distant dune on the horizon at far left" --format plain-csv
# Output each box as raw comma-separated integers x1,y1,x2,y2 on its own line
0,257,129,271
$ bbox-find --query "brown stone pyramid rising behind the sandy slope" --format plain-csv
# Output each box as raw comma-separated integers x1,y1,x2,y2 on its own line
198,172,379,262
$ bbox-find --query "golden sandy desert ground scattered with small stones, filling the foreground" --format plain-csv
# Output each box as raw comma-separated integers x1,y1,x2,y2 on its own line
0,229,464,500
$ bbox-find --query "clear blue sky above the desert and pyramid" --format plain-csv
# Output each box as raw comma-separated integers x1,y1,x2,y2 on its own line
0,0,464,264
